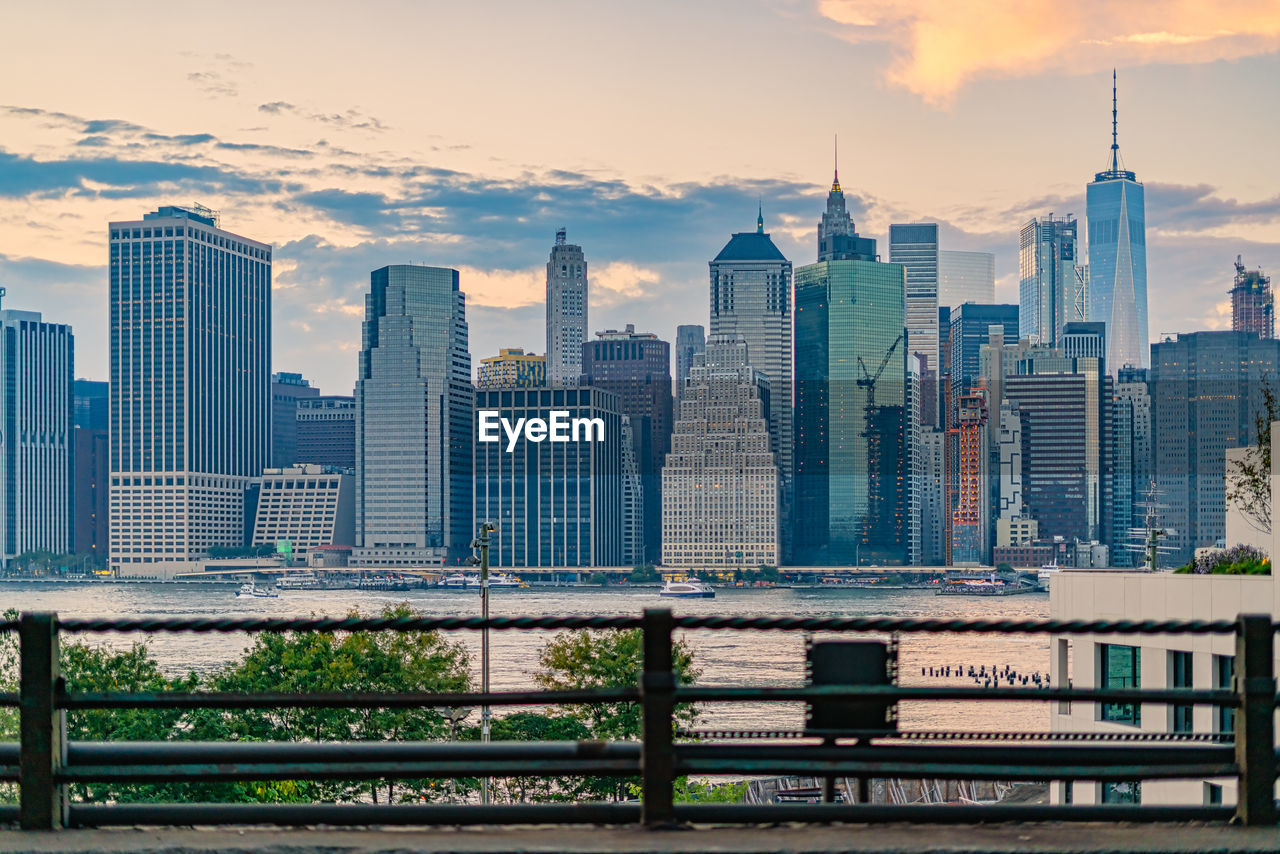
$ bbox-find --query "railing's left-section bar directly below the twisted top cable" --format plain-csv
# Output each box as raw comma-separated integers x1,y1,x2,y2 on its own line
59,688,640,709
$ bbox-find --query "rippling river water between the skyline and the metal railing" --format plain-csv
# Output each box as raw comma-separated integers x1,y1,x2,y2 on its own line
0,583,1048,731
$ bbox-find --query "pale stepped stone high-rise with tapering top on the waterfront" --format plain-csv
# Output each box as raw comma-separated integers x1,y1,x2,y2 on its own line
662,334,781,571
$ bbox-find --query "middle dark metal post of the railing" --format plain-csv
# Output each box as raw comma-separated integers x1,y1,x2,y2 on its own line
640,608,676,827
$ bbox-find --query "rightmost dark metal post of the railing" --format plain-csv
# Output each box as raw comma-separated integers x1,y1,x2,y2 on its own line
1233,615,1276,825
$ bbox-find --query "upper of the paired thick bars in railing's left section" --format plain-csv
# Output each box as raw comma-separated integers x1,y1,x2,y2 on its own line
67,741,641,766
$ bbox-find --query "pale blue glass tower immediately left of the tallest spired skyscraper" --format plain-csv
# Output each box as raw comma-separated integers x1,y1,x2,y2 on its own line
1018,214,1088,347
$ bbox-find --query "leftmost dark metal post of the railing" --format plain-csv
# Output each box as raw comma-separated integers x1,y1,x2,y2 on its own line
18,611,67,830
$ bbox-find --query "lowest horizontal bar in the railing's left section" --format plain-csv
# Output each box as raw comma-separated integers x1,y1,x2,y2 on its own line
69,803,637,827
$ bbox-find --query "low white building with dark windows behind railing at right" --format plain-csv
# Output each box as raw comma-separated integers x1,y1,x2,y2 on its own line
1050,423,1280,805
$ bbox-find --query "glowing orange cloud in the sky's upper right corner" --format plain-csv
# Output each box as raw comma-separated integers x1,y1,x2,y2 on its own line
818,0,1280,104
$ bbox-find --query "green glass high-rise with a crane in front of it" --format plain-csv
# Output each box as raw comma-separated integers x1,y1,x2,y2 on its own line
795,250,910,566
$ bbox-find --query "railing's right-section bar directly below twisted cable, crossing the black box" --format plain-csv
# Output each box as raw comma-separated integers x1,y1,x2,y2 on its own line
676,685,1240,705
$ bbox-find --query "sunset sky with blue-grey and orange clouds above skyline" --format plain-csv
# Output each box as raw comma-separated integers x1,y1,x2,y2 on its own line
0,0,1280,393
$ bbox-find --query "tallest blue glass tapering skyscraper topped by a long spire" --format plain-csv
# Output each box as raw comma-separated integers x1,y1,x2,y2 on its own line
1084,72,1148,376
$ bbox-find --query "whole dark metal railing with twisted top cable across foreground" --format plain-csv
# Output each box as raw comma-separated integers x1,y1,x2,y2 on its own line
0,609,1277,830
